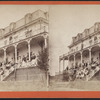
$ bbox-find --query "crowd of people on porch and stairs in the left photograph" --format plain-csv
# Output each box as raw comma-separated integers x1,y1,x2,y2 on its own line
0,52,37,75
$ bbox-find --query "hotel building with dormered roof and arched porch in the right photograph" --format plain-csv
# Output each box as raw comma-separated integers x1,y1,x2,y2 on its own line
59,22,100,80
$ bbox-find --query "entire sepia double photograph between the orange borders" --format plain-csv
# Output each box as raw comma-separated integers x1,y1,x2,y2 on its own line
0,5,100,91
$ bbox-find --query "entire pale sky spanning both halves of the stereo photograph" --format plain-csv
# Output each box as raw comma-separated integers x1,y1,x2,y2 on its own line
0,5,100,75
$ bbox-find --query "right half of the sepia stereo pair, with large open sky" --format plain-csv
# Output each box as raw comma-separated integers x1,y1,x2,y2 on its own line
49,5,100,91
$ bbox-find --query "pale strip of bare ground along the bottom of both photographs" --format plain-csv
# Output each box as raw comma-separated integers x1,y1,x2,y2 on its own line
0,81,97,91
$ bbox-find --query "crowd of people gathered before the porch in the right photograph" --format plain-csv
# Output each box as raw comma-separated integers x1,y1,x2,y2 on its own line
63,58,100,81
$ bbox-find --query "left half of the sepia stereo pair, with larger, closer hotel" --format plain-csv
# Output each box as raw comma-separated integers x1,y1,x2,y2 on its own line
0,5,49,91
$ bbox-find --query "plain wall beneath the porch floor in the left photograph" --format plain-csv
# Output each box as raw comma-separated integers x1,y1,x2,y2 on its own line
4,67,46,82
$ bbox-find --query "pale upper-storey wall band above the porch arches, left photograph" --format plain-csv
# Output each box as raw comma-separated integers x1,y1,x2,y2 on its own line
0,26,48,48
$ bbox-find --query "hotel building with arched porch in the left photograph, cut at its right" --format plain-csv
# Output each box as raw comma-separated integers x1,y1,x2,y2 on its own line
0,10,48,81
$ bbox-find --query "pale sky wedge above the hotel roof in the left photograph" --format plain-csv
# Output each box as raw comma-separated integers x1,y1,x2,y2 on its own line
0,5,48,28
